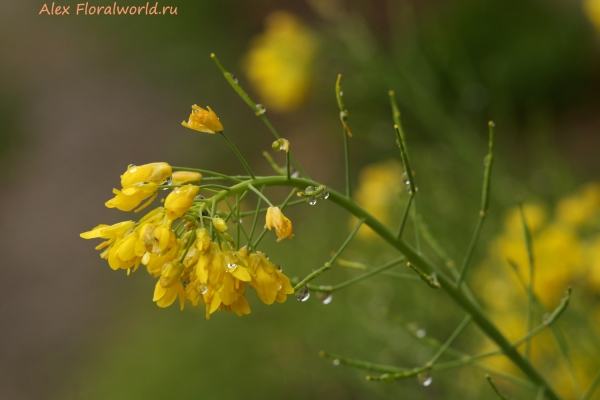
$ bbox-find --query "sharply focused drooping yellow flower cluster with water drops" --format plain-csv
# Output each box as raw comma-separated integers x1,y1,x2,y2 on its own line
81,163,294,318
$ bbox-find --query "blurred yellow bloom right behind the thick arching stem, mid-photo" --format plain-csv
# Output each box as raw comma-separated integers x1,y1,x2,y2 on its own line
350,160,404,239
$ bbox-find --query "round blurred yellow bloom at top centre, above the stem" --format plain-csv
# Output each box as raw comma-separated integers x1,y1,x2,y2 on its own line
244,11,317,112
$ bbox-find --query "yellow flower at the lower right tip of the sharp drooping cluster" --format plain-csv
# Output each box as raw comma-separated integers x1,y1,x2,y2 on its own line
248,252,294,305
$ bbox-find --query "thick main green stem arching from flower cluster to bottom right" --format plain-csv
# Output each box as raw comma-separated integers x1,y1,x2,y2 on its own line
206,176,560,400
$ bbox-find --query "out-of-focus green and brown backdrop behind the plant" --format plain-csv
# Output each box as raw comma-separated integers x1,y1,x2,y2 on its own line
0,0,600,399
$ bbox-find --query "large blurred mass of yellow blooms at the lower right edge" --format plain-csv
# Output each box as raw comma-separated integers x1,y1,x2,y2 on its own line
475,183,600,398
